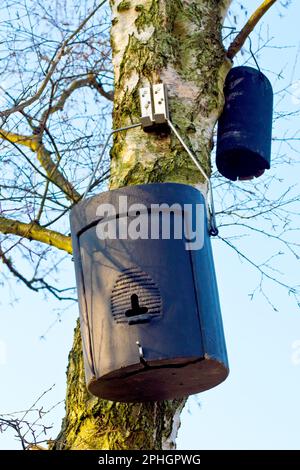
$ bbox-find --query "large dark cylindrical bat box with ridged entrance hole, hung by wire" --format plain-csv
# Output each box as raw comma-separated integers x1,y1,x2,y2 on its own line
71,183,228,402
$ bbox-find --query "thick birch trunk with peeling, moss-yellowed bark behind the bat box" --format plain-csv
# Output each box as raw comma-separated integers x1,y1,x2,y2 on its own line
54,0,231,450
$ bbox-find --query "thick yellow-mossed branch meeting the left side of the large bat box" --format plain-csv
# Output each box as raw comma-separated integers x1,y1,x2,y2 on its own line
0,217,72,254
